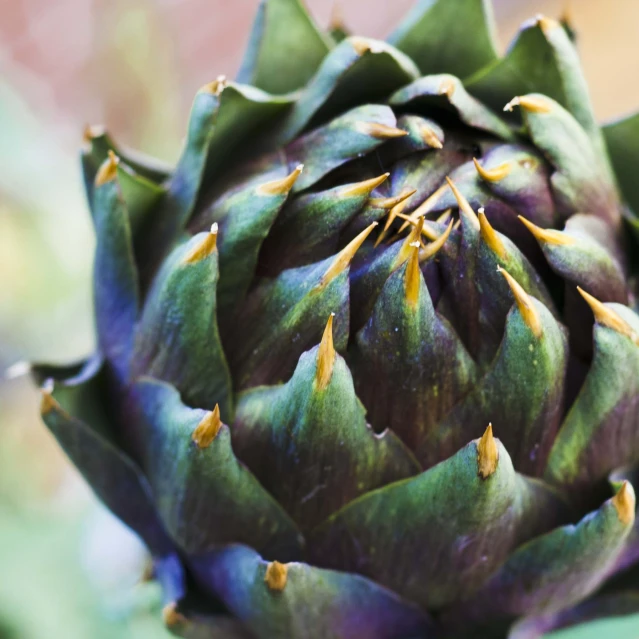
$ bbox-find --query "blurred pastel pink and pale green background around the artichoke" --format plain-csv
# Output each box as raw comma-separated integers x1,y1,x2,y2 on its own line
0,0,639,639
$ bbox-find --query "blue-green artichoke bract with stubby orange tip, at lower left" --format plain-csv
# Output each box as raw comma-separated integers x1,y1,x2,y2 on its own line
132,378,302,559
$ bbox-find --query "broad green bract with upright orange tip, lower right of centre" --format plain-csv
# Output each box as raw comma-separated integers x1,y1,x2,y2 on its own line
309,431,564,608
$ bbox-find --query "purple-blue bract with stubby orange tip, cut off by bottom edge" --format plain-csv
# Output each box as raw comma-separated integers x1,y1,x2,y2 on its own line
191,545,434,639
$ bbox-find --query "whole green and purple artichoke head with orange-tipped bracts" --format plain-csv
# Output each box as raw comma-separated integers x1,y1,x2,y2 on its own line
33,0,639,639
